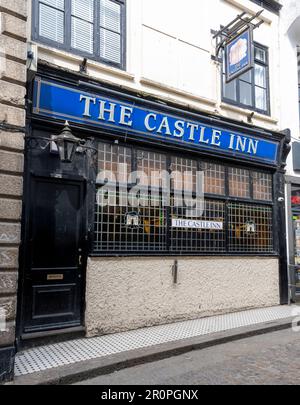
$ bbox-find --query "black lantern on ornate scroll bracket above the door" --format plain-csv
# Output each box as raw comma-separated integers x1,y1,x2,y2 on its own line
26,121,97,163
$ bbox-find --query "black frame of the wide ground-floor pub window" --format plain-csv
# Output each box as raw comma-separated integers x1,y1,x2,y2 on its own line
91,138,278,257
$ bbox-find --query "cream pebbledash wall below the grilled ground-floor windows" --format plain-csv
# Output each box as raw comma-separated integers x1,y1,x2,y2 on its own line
86,257,280,336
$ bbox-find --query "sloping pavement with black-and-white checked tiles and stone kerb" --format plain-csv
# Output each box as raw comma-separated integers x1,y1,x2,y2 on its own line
11,306,300,385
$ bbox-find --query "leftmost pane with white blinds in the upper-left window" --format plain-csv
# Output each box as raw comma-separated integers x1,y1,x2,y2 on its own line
39,4,64,44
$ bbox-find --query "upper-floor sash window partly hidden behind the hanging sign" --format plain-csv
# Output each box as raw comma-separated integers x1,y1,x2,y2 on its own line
223,44,270,115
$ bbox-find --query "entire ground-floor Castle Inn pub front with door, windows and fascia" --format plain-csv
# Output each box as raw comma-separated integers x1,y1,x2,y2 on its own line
18,68,288,340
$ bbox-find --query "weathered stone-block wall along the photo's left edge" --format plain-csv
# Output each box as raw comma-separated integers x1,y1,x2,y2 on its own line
0,0,27,380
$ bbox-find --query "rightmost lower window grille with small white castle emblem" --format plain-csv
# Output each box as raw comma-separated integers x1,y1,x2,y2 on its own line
228,203,273,253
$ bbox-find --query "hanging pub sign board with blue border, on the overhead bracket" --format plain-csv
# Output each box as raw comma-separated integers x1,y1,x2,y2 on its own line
225,28,254,83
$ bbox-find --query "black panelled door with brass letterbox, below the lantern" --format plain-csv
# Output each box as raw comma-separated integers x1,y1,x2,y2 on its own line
21,175,86,334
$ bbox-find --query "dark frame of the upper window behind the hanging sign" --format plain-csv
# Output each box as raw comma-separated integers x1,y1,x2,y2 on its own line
221,42,271,116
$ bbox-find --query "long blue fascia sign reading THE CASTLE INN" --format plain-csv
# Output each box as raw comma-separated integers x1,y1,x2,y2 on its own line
33,77,279,166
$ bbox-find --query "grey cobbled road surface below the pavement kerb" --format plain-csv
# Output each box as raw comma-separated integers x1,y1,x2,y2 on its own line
76,329,300,384
